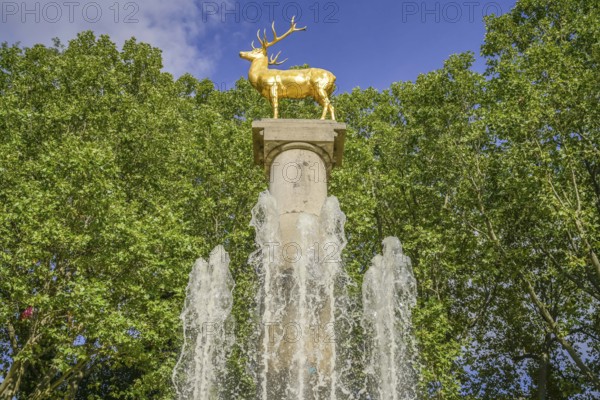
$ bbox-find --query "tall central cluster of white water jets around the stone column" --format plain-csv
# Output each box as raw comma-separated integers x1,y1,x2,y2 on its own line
250,191,346,400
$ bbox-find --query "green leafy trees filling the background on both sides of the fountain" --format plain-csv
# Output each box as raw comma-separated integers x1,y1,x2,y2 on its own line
0,0,600,399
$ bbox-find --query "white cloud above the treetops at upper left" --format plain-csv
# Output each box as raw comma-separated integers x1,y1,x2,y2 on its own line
0,0,220,77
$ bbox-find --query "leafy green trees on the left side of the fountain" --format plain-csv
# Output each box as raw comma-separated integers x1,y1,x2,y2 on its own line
0,32,262,399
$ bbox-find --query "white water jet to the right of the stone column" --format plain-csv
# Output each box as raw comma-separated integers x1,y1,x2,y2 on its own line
362,237,417,400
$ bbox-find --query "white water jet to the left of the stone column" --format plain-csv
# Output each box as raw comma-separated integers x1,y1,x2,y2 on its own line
173,246,234,400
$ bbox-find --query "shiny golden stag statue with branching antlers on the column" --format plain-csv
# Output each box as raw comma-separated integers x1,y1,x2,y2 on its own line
240,18,335,121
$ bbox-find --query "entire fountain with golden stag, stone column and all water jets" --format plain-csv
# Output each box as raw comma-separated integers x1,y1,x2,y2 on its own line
173,18,417,400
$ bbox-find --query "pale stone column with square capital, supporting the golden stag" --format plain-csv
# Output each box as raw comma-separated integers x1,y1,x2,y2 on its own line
252,119,346,400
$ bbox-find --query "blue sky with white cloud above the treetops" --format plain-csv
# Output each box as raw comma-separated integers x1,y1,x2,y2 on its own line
0,0,515,91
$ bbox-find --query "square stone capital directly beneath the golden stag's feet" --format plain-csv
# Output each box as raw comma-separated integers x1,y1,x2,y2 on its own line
252,118,346,175
